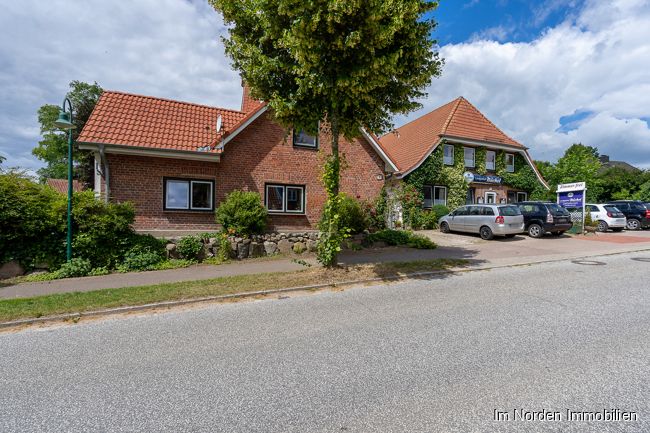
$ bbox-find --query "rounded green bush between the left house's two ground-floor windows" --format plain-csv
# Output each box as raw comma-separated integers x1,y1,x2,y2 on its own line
216,191,268,236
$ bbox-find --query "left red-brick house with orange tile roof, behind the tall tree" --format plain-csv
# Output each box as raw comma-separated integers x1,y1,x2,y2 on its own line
78,87,397,236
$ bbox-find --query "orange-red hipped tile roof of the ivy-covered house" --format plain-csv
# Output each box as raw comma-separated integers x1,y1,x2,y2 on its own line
379,96,525,173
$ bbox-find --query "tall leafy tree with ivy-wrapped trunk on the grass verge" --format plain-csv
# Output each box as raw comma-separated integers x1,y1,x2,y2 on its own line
210,0,442,265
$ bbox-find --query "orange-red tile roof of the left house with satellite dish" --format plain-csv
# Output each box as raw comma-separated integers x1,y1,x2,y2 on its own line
77,91,246,153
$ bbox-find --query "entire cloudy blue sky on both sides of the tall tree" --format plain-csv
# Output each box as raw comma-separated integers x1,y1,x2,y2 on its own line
0,0,650,171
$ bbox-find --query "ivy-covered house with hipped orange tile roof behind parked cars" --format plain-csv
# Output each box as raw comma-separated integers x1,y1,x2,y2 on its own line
379,97,548,208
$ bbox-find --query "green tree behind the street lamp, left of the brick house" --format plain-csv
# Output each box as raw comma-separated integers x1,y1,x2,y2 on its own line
32,81,103,186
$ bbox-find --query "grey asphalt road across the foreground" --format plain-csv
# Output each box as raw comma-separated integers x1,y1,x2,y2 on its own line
0,252,650,433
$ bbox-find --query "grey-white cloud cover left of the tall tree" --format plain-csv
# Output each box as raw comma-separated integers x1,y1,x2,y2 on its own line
0,0,241,169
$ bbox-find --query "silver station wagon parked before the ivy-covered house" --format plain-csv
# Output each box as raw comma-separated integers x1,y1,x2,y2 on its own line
438,204,524,240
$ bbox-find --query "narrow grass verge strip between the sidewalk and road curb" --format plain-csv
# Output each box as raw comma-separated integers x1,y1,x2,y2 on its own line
0,259,467,322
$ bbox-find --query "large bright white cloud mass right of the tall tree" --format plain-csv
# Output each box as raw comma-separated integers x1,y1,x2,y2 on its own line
398,0,650,168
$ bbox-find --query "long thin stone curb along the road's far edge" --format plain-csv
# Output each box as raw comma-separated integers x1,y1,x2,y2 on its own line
0,248,650,329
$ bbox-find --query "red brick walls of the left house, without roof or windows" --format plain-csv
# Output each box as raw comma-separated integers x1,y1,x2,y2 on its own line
102,114,384,231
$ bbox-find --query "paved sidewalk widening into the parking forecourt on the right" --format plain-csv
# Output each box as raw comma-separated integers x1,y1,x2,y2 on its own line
0,231,650,299
